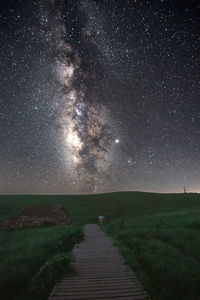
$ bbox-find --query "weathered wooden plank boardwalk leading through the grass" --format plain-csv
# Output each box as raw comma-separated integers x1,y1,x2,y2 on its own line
49,224,150,300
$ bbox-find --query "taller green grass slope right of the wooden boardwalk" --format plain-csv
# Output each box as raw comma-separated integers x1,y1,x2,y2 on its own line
103,210,200,300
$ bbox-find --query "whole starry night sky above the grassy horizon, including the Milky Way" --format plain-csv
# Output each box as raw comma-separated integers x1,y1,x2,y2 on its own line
0,0,200,194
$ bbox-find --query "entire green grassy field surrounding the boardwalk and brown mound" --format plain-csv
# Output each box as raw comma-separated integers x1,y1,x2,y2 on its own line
0,192,200,300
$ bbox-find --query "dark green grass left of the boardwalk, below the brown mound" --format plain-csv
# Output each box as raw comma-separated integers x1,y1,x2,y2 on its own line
0,226,83,300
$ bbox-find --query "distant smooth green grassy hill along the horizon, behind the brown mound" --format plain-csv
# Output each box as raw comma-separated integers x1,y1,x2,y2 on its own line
0,192,200,224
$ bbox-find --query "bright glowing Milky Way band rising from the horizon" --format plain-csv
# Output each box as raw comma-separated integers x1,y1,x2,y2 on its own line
47,2,116,191
